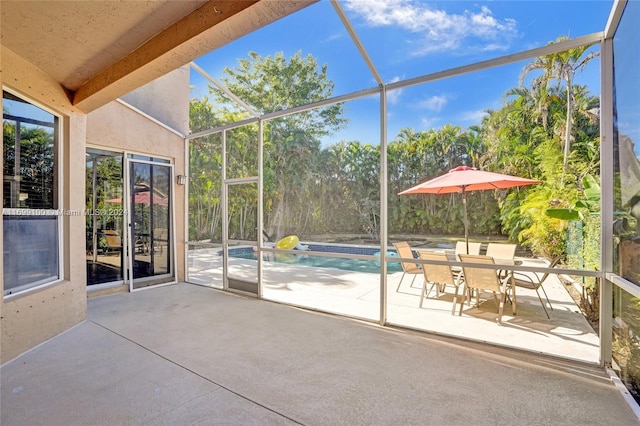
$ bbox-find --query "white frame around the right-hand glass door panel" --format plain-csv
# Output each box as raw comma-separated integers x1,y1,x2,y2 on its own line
123,158,178,292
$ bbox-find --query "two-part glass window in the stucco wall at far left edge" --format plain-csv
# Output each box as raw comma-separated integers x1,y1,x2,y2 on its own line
2,91,60,295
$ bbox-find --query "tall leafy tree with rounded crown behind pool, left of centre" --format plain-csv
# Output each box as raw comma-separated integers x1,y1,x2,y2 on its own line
211,52,347,237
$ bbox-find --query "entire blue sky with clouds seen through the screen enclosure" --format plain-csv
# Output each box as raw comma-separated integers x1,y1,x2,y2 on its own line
192,0,613,144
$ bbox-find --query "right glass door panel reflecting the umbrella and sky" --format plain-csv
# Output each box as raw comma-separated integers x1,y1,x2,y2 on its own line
128,160,175,290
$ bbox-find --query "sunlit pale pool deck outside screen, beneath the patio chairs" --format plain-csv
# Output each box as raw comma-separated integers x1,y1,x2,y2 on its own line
188,250,600,364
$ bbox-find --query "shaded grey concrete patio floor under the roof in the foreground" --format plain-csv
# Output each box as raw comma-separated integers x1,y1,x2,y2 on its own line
0,283,638,426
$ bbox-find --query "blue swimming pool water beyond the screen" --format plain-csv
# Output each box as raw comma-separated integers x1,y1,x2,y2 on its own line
229,244,402,274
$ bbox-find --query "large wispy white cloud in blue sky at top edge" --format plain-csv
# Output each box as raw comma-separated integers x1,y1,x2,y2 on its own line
344,0,517,56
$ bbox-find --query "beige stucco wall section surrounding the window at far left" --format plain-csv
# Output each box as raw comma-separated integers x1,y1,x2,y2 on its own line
0,47,87,363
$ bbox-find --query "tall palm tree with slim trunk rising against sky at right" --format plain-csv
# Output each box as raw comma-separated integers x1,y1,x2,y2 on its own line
520,36,600,169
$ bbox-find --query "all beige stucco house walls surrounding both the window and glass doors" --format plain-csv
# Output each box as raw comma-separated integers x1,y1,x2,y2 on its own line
0,47,189,363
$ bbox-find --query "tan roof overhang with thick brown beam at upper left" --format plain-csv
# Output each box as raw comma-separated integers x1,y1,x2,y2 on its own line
0,0,318,113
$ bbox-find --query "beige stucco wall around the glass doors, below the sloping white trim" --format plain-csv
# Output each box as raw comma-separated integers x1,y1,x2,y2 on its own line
87,94,188,281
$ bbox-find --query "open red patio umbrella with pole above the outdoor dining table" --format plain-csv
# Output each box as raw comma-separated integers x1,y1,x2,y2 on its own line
398,166,540,252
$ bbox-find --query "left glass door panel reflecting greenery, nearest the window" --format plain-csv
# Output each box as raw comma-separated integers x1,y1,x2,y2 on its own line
85,148,126,286
